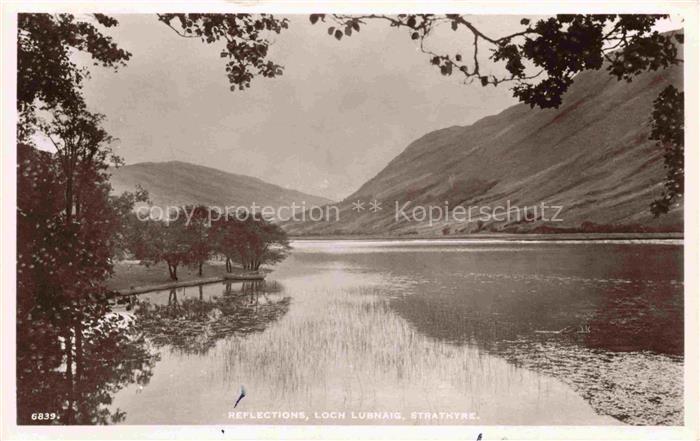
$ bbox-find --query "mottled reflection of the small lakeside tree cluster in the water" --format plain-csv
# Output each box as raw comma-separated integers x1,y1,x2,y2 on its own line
133,281,290,355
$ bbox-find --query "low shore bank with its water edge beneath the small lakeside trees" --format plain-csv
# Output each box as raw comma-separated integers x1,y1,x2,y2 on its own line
107,261,265,295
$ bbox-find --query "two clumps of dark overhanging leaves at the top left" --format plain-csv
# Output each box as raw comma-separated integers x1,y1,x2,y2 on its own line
17,13,289,143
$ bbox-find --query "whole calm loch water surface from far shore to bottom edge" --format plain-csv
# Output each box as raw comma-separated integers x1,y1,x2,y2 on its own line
109,241,683,425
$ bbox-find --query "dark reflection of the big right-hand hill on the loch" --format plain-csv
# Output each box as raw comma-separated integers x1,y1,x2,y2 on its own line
346,244,683,424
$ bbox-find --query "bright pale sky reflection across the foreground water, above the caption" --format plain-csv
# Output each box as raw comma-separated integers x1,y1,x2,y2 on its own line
108,274,615,424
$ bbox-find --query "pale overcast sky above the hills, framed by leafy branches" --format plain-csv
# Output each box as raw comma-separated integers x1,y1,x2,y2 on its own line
79,14,680,200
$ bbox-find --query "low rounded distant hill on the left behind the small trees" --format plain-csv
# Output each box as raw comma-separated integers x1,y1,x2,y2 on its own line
110,161,331,212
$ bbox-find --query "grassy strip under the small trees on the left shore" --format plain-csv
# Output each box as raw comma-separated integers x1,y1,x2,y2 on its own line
107,261,262,291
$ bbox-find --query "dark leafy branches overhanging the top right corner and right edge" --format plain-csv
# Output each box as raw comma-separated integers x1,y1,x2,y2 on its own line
309,14,684,216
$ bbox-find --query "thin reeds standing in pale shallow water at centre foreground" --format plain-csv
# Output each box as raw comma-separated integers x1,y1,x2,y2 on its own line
216,286,604,423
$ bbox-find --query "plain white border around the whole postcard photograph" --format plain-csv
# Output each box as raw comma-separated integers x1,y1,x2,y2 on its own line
0,0,700,440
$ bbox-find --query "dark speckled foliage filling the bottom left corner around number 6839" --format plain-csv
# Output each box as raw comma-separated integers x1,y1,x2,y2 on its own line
17,305,158,424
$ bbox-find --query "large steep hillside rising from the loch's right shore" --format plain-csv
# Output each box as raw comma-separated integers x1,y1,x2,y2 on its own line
285,41,683,235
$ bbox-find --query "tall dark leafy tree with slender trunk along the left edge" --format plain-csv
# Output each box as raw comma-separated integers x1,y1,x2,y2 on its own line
17,102,142,422
